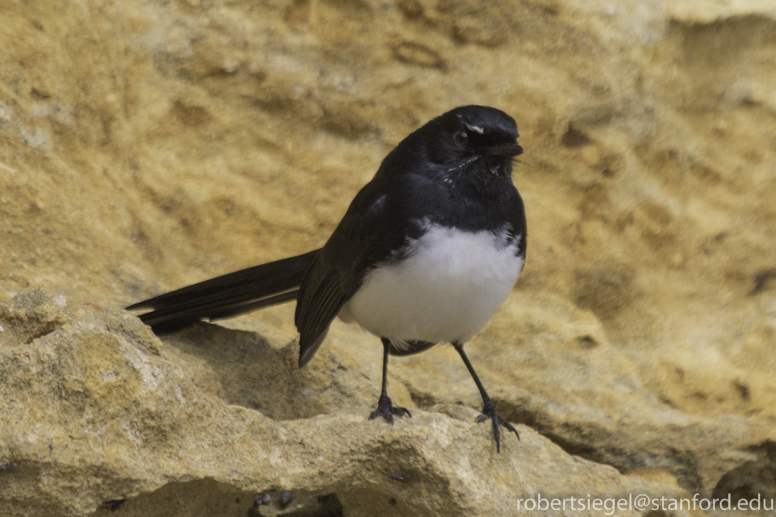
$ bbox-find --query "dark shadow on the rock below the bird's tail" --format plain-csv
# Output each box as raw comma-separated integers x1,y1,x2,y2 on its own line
163,323,379,420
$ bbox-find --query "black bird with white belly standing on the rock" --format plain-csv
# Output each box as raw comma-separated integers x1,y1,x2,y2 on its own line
127,105,527,453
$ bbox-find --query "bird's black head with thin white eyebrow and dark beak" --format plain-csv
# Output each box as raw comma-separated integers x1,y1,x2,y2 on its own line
418,106,523,186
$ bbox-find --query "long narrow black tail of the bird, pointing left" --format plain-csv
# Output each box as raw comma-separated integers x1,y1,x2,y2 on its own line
127,250,320,331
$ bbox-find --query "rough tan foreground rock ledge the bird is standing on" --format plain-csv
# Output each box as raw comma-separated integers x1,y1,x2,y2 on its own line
0,294,704,516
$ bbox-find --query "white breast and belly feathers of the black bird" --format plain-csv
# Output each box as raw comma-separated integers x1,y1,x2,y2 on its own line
339,225,524,343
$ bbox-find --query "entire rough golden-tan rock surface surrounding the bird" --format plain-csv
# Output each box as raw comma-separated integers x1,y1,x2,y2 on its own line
0,0,776,516
